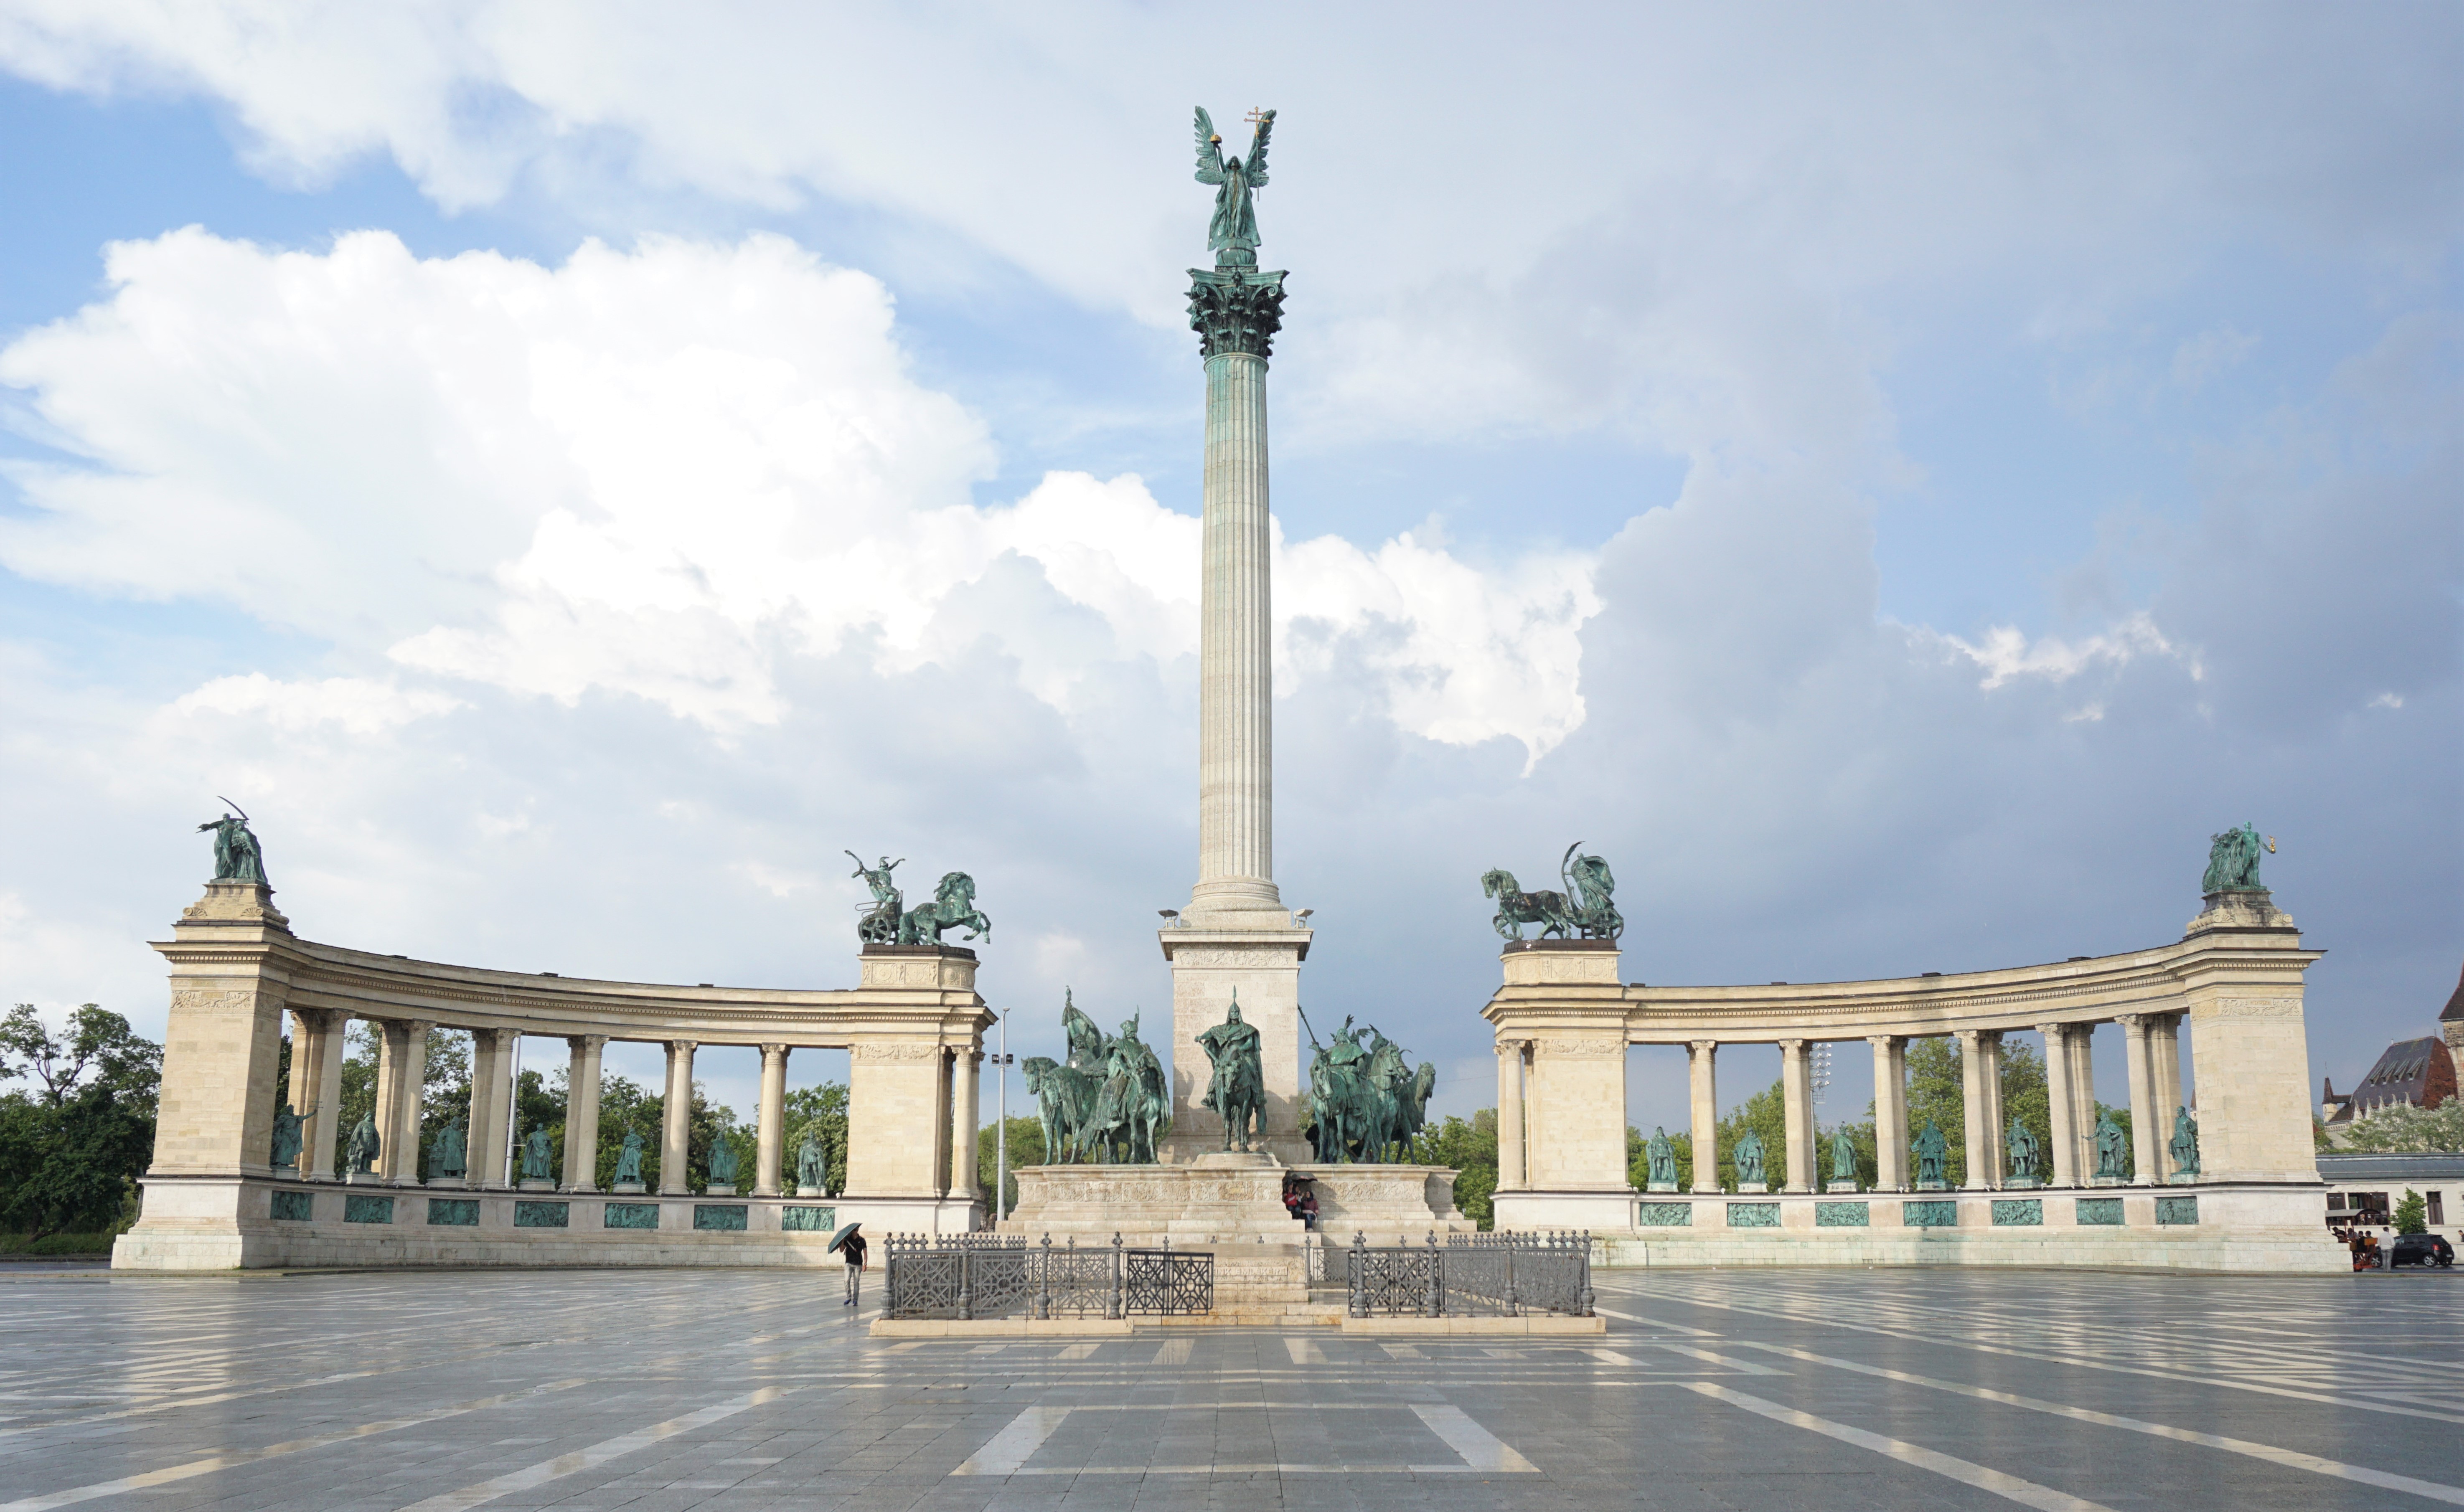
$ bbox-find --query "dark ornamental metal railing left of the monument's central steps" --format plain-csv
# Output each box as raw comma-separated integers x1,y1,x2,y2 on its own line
884,1234,1215,1320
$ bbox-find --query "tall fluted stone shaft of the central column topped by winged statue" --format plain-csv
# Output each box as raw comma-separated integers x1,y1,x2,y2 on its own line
1190,352,1281,913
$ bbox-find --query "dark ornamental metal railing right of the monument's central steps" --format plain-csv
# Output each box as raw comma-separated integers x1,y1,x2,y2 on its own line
1350,1231,1592,1317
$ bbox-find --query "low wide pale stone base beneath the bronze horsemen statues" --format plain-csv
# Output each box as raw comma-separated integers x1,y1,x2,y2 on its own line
1001,1150,1473,1246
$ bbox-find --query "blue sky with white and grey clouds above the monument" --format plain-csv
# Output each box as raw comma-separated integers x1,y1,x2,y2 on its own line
0,0,2464,1128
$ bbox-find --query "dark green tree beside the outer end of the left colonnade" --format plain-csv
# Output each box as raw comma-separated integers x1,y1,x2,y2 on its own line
0,1002,163,1239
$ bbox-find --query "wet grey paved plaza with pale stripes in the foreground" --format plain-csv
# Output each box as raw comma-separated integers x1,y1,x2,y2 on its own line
0,1271,2464,1512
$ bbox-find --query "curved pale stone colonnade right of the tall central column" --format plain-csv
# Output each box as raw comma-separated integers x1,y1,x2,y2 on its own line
1483,894,2341,1268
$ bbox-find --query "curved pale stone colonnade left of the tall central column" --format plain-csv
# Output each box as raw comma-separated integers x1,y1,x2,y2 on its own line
113,882,993,1271
